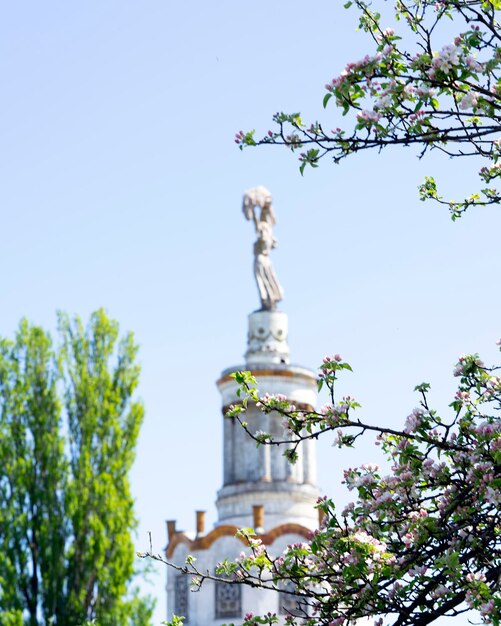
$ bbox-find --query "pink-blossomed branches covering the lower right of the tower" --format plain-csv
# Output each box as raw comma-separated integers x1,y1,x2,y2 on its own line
154,348,501,626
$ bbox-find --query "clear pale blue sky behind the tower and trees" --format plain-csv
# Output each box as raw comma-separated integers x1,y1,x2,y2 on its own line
0,0,501,623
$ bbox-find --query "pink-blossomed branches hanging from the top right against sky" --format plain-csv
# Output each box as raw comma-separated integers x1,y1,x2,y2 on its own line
235,0,501,219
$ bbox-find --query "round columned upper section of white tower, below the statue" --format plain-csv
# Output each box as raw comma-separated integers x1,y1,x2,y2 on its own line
216,311,318,529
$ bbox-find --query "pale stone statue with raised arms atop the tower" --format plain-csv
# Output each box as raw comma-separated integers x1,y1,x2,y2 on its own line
242,186,284,311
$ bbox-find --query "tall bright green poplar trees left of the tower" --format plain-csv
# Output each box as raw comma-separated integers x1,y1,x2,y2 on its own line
0,310,152,626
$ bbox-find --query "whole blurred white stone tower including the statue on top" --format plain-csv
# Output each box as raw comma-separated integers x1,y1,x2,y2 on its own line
166,187,319,626
